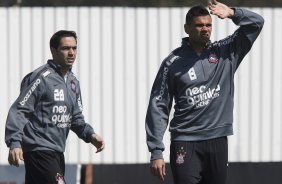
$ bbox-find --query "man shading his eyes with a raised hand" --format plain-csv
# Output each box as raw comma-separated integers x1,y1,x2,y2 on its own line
146,0,264,184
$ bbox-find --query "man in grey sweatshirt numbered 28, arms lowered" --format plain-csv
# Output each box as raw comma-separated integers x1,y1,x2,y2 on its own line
5,30,105,184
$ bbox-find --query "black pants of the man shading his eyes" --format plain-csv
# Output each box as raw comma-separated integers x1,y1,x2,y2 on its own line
170,137,228,184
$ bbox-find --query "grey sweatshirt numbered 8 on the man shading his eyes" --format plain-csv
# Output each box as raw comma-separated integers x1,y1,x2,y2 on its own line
146,8,264,160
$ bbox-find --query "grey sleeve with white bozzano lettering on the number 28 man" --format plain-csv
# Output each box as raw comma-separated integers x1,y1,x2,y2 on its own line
5,72,45,149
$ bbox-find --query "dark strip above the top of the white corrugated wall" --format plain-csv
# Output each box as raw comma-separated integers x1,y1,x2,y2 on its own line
0,0,282,7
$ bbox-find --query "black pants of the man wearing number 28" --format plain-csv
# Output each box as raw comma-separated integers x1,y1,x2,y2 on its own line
23,151,65,184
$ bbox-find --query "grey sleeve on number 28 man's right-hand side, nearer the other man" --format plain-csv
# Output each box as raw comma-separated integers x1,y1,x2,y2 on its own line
71,81,95,143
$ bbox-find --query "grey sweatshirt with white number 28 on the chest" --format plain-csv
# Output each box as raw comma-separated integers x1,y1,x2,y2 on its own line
5,60,94,152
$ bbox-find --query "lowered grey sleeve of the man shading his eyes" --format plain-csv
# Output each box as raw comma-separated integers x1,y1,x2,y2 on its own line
145,56,173,160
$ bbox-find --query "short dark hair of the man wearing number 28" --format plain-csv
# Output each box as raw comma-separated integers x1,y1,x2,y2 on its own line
50,30,77,50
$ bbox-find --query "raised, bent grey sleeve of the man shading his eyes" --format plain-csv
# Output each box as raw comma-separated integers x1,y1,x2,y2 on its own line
221,8,264,69
